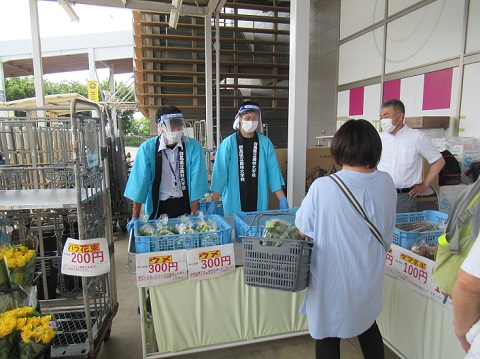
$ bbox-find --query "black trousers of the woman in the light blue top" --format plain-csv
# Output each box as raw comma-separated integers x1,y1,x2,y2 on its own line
315,322,385,359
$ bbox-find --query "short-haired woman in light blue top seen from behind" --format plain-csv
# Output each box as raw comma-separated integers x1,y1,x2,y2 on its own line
295,120,397,359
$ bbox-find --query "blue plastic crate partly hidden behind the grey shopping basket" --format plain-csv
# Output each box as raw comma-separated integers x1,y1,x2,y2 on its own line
233,207,299,242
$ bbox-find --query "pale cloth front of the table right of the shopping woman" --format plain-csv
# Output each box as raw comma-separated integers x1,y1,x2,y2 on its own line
377,275,465,359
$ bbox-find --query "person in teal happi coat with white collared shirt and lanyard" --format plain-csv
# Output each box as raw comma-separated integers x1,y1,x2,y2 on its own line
124,106,208,230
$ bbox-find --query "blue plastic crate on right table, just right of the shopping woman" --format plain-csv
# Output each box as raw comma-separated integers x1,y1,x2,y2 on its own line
393,211,448,249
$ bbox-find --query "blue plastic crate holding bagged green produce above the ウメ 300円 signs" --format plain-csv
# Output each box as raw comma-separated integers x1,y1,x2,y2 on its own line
134,214,232,253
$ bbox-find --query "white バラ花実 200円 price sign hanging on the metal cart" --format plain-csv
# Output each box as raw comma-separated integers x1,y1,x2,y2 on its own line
61,238,110,277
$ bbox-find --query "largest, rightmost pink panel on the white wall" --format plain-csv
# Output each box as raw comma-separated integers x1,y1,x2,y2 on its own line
422,69,453,110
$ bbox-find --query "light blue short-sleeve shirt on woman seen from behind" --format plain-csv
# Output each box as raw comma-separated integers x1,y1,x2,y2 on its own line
295,170,397,339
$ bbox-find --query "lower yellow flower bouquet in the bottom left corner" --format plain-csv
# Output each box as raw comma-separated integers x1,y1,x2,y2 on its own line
0,307,55,359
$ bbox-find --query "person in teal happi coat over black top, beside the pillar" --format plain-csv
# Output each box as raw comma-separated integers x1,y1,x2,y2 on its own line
207,101,288,216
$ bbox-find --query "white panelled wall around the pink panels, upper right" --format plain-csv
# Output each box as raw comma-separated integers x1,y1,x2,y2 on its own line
337,0,480,142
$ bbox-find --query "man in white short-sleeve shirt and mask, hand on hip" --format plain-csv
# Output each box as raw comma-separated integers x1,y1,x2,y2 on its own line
378,99,445,213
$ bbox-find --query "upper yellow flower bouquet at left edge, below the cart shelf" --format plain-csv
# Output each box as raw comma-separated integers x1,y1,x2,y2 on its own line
1,245,36,287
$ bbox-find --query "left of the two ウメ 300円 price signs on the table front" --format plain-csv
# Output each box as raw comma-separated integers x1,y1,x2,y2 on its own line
136,249,187,287
